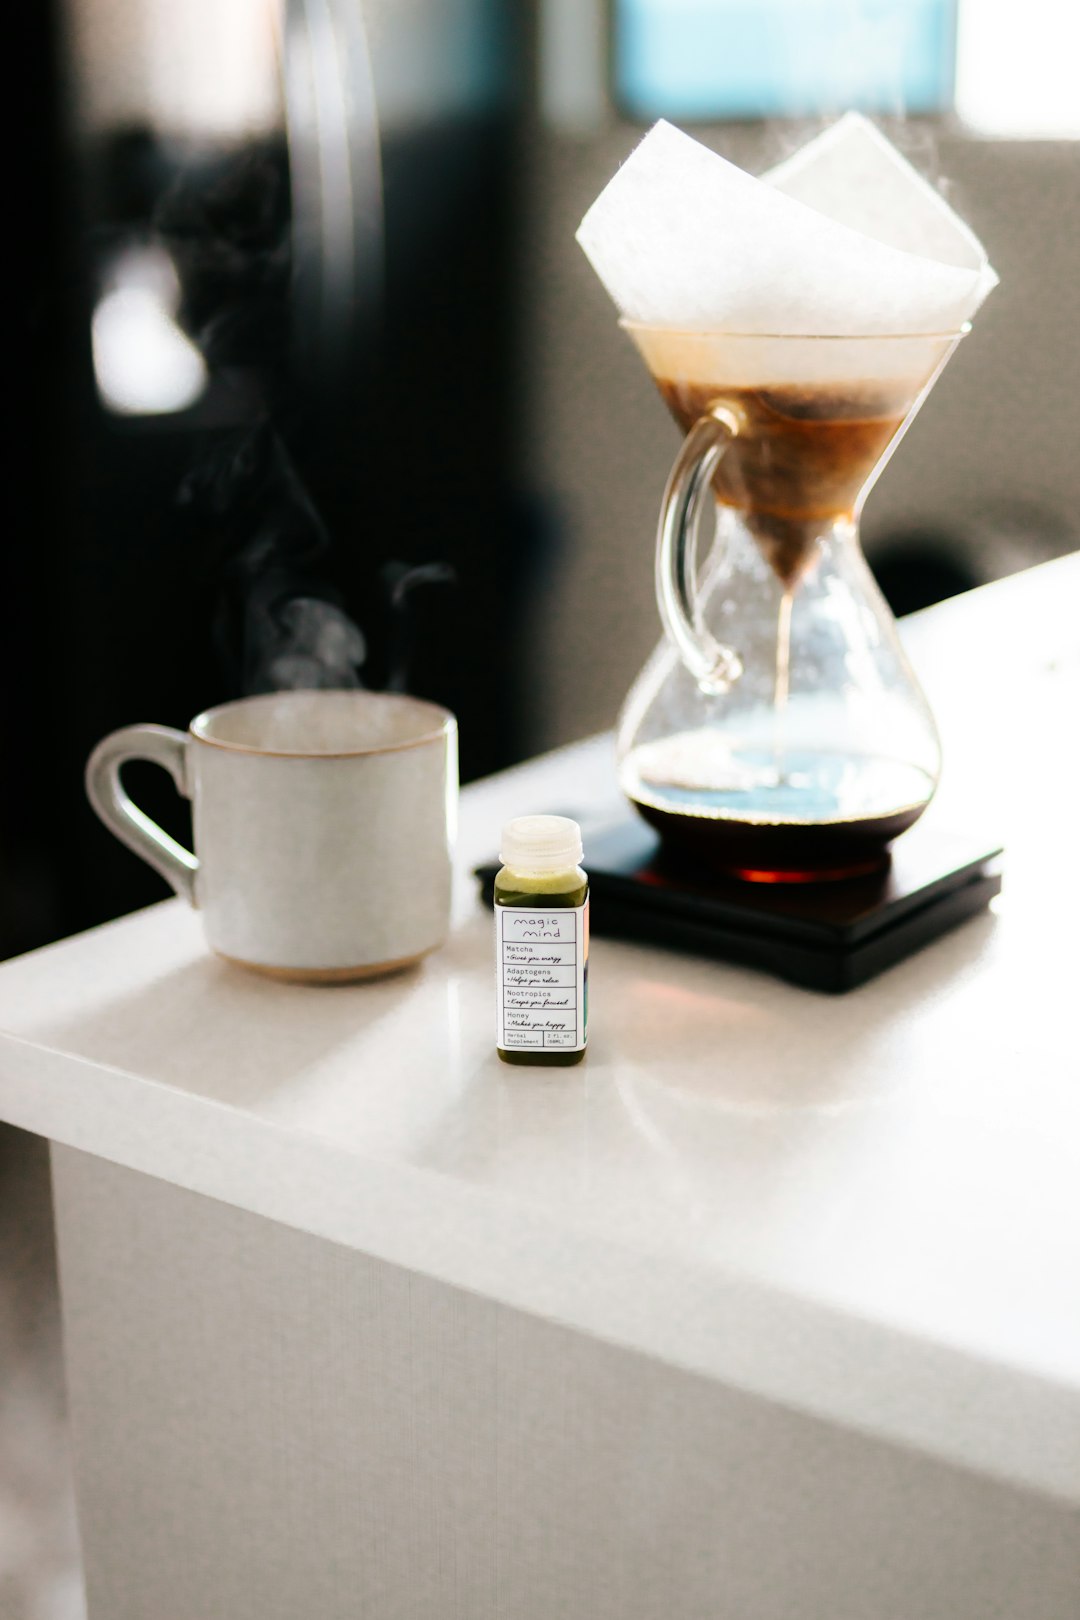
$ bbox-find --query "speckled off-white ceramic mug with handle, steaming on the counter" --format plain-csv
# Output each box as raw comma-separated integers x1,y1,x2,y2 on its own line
86,692,458,980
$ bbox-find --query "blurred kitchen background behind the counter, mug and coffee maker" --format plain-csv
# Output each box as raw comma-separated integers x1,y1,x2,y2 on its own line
0,0,1080,1620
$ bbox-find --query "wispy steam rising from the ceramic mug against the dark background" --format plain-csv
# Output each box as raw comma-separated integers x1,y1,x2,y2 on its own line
155,139,449,695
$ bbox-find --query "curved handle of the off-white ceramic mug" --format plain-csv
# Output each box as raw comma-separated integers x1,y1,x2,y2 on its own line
86,726,199,906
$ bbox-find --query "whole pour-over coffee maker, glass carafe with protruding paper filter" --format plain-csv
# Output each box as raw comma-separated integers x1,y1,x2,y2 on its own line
578,115,996,885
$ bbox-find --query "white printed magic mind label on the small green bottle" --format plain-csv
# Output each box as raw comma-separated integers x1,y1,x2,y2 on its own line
495,901,589,1051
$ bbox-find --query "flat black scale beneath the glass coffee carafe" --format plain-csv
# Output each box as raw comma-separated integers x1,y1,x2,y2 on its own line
476,816,1002,993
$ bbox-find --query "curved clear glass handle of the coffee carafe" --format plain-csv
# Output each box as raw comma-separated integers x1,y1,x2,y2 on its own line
656,399,743,693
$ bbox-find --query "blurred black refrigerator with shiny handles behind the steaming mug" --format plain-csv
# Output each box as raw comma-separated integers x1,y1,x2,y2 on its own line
14,0,528,954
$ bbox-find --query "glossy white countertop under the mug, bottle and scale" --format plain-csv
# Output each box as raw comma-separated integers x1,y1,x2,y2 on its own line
0,557,1080,1503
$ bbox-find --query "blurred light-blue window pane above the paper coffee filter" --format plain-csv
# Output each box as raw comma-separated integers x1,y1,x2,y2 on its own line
614,0,957,122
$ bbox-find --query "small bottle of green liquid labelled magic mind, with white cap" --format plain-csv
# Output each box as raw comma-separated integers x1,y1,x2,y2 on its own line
495,815,589,1066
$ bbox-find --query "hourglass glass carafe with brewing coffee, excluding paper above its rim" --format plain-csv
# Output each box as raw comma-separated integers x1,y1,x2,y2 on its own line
617,322,960,881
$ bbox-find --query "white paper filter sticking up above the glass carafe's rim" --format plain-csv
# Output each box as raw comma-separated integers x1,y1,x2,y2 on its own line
578,115,997,381
